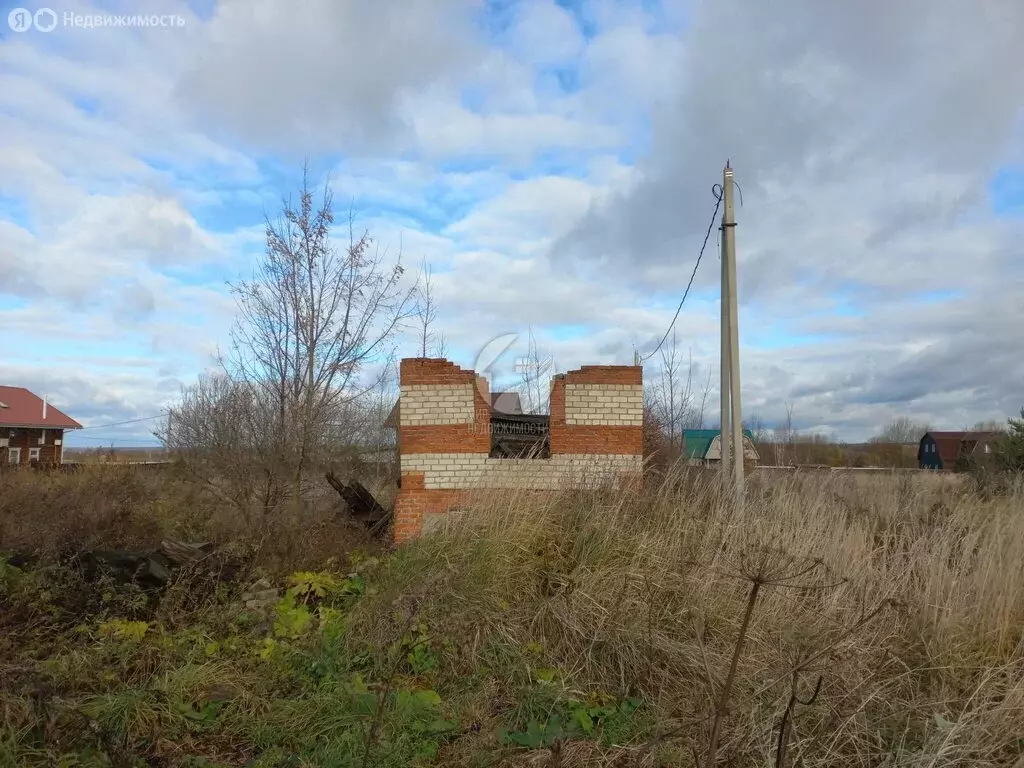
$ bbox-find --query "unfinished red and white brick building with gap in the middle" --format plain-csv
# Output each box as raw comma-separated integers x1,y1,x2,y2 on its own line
394,357,643,542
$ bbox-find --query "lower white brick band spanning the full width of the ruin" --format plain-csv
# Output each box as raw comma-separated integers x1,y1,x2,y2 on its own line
401,454,643,490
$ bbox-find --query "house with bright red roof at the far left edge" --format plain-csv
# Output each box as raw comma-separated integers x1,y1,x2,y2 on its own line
0,386,82,466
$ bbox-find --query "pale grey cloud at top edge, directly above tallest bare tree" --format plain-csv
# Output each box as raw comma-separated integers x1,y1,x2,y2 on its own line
176,0,481,153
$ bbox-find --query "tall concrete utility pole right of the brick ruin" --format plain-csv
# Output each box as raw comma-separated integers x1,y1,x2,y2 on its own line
722,162,743,499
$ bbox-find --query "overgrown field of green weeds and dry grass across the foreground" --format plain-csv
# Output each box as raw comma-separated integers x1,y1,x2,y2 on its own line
0,470,1024,767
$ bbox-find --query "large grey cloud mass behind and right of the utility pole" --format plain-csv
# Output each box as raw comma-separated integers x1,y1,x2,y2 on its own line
552,0,1024,433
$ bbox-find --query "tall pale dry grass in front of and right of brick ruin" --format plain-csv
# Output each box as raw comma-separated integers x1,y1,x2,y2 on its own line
360,472,1024,766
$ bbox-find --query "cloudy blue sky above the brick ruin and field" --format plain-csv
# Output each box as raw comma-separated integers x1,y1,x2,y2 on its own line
0,0,1024,445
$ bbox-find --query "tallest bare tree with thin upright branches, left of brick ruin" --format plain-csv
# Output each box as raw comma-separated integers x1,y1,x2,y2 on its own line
163,171,415,518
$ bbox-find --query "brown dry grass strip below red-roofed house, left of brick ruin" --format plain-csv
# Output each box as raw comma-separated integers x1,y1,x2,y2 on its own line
0,464,376,571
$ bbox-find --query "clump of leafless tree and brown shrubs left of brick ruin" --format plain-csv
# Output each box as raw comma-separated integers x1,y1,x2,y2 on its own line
160,173,411,523
